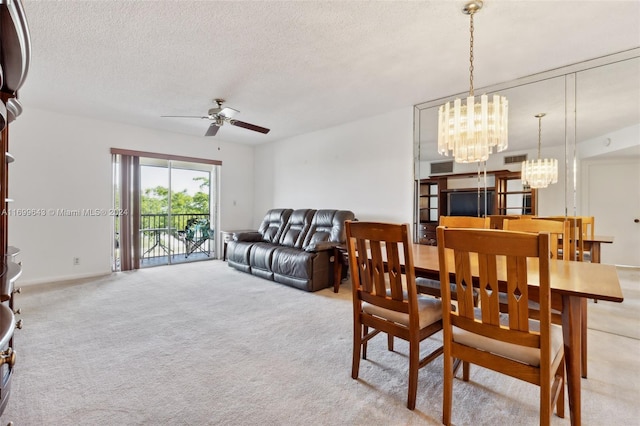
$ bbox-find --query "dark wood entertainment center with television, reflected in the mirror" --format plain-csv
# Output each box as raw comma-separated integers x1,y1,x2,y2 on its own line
414,170,537,245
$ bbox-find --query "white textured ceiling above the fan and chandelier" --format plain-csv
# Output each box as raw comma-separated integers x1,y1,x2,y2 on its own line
20,0,640,144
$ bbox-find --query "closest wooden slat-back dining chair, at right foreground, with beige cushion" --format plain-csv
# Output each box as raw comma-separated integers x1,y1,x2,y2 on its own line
437,226,565,425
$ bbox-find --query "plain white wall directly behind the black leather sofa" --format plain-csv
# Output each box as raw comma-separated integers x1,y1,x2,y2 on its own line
254,107,413,225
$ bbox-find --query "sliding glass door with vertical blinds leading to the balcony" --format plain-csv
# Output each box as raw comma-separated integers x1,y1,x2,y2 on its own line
112,150,220,270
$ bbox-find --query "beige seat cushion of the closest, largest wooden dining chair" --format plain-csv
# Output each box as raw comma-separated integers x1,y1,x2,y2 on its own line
453,308,564,367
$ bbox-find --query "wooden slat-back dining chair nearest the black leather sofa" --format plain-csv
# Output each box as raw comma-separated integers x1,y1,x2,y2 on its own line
345,221,442,410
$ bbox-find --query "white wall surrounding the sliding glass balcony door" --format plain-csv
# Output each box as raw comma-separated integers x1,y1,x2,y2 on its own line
9,108,254,285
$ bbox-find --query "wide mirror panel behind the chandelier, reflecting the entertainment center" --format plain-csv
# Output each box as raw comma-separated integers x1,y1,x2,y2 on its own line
415,76,566,238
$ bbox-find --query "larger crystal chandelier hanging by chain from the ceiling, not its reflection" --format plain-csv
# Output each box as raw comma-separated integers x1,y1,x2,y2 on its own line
438,1,509,163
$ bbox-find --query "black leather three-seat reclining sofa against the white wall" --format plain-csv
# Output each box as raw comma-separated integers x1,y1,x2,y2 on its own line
227,209,355,291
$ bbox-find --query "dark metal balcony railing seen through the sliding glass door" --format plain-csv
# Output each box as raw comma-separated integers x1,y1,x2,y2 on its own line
140,213,214,265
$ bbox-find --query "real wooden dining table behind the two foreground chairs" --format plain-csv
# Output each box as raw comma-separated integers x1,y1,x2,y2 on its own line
413,244,624,425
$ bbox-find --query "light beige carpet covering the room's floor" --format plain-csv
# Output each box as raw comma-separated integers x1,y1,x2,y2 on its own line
0,261,640,426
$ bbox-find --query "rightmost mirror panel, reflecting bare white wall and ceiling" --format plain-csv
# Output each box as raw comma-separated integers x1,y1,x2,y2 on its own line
576,57,640,266
